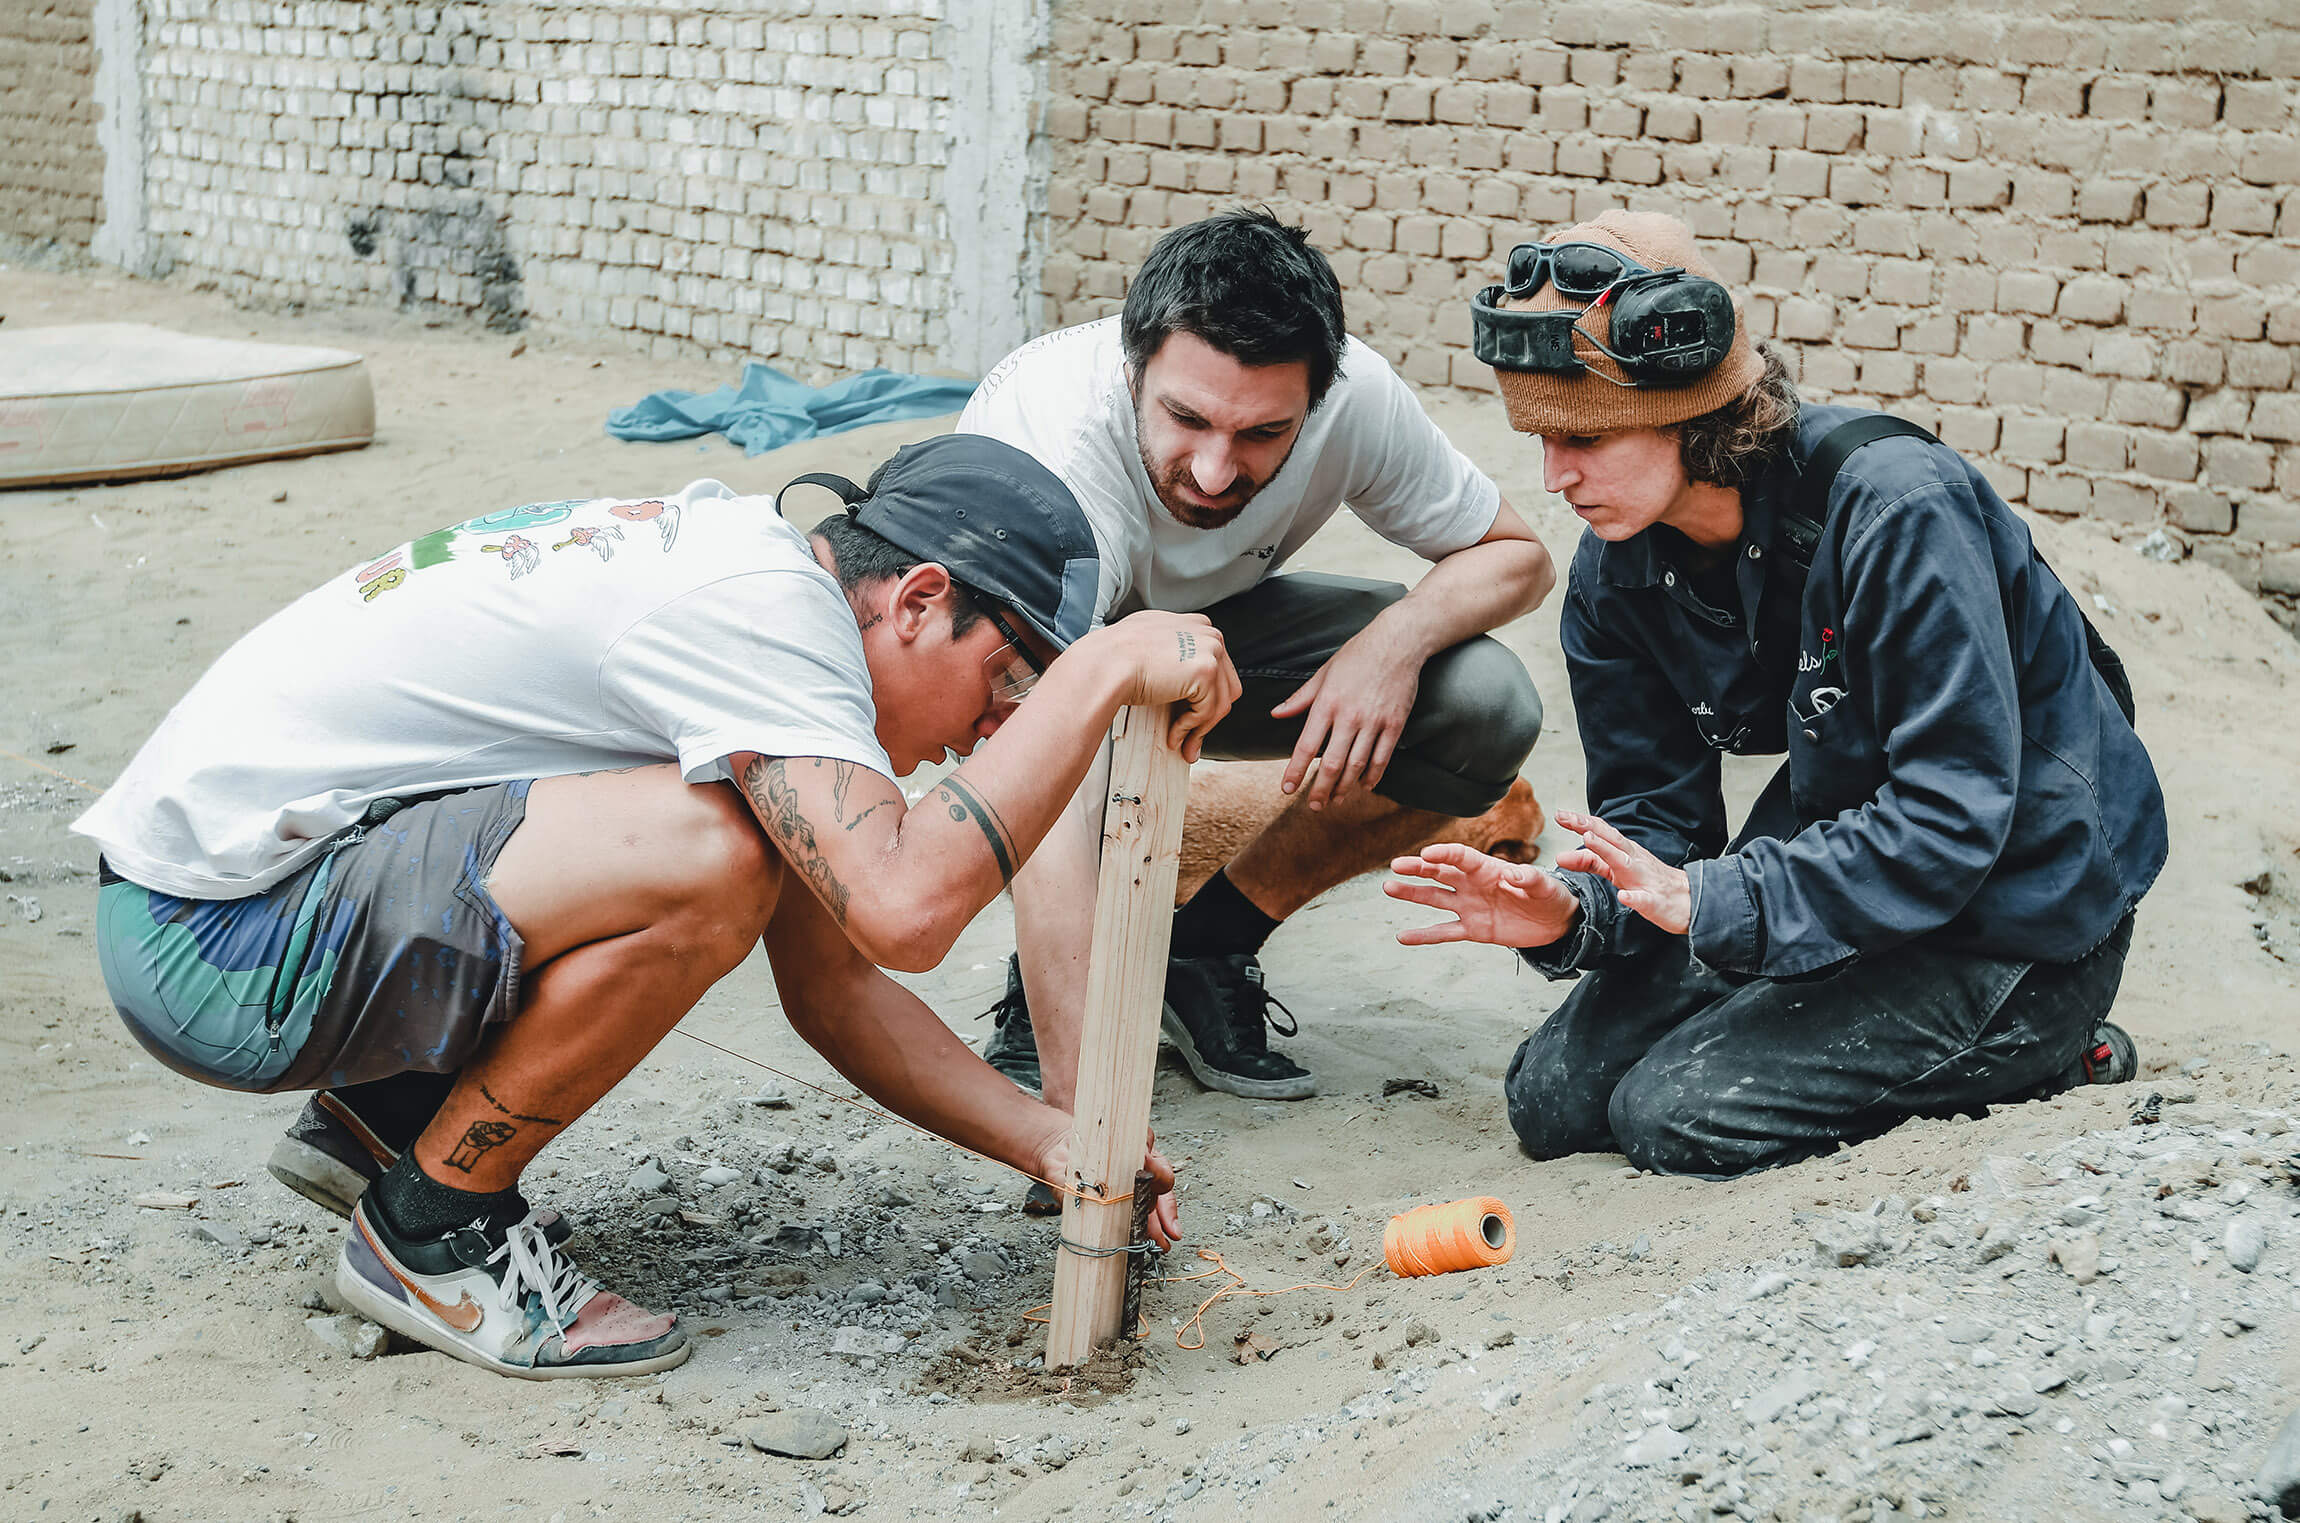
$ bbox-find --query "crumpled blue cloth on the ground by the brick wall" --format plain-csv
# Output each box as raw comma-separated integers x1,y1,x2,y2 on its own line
607,361,975,456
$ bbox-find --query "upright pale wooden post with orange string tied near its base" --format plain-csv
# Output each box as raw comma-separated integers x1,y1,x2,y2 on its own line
1047,706,1189,1369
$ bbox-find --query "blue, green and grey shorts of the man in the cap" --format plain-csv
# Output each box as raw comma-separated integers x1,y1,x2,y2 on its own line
97,782,529,1093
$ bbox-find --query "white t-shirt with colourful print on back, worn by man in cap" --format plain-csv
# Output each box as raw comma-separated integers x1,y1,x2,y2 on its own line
71,481,892,900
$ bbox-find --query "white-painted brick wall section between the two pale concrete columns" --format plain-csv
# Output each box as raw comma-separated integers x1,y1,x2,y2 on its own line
145,0,952,373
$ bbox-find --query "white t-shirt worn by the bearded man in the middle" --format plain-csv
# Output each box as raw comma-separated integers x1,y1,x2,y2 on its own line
959,317,1502,619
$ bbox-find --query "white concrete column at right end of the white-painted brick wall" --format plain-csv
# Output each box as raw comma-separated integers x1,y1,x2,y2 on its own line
936,0,1049,375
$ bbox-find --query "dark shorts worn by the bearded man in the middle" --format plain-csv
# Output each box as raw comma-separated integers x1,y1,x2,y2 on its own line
1198,571,1541,814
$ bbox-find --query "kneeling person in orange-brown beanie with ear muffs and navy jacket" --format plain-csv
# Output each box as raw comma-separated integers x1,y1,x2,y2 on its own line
1387,212,2167,1178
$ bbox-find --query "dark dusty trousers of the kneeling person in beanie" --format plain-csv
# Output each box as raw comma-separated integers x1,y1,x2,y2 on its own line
1504,916,2132,1178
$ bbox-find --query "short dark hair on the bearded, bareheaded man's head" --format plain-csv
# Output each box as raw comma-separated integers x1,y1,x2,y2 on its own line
1118,207,1346,410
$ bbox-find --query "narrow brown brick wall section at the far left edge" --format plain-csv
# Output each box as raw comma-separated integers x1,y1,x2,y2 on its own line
0,0,104,248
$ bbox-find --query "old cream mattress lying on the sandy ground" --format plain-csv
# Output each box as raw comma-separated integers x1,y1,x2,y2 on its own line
0,322,375,488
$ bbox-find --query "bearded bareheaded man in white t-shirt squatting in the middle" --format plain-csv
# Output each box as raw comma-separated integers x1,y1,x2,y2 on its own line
959,209,1555,1159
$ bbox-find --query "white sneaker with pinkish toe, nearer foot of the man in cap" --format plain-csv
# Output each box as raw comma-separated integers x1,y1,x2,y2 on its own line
336,1199,695,1380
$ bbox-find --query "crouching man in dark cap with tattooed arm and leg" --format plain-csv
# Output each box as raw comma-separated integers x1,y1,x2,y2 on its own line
76,437,1237,1376
